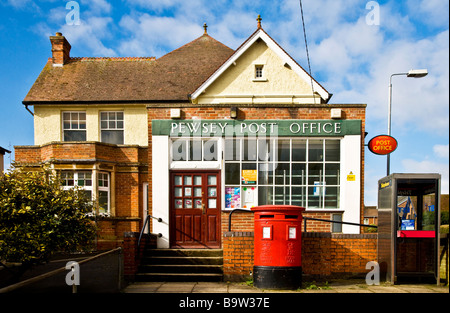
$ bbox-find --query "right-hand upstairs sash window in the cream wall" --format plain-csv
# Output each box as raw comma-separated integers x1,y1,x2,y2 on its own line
100,111,124,145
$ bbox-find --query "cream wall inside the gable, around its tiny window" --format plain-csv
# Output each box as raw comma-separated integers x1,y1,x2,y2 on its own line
198,41,320,103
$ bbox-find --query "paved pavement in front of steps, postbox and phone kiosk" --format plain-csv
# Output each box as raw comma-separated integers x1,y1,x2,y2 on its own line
122,280,449,294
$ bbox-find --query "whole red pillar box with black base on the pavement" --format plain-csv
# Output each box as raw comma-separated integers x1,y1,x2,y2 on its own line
252,205,305,289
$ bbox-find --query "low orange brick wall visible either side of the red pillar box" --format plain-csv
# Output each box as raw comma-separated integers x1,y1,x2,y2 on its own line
222,232,377,281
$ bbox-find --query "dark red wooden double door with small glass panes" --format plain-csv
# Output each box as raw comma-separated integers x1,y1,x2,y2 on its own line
170,171,221,248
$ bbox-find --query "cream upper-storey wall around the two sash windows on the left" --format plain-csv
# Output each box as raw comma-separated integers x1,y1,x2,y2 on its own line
34,105,148,146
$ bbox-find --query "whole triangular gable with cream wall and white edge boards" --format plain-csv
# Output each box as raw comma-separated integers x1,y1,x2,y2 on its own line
191,28,331,103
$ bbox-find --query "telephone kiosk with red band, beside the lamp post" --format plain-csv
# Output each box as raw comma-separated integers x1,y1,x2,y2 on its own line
378,174,441,284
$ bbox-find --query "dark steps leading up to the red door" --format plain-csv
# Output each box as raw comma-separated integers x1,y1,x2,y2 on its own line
136,249,223,282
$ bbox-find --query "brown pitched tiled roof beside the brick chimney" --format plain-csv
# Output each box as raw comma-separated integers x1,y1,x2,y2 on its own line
23,34,234,104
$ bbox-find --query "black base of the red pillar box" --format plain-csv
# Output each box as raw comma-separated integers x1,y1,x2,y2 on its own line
253,266,302,290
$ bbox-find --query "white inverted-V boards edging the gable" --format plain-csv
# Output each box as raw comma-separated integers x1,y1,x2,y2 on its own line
191,28,330,101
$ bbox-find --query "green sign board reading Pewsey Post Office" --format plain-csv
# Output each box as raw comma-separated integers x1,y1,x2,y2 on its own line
152,120,361,137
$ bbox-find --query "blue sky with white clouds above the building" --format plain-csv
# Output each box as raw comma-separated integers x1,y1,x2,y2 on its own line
0,0,449,205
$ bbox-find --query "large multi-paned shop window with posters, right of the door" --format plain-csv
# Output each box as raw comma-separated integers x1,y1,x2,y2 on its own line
224,138,340,209
